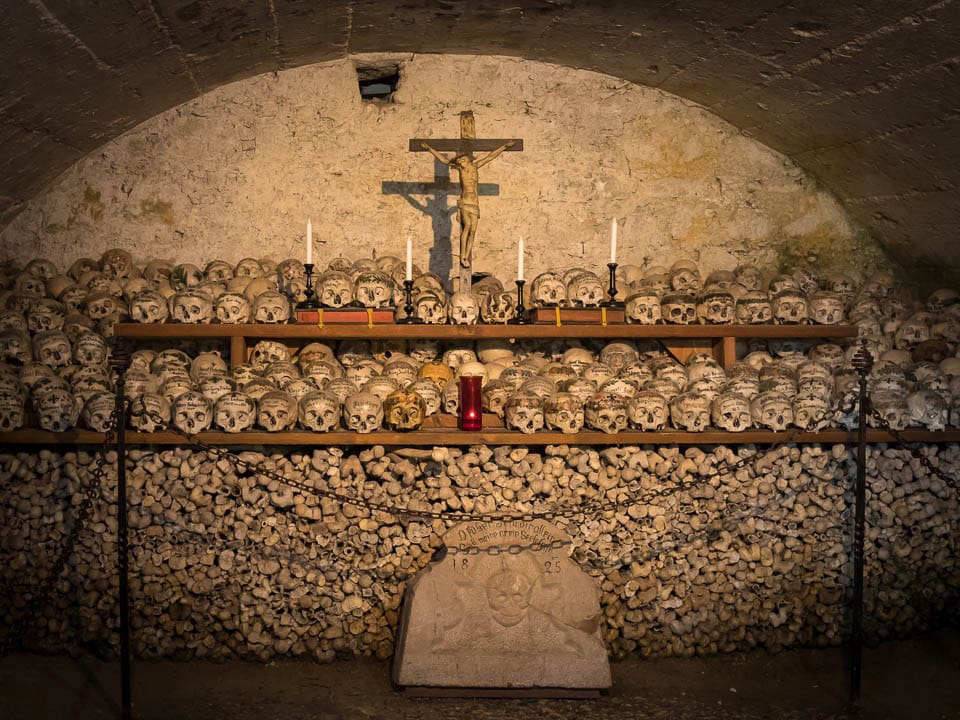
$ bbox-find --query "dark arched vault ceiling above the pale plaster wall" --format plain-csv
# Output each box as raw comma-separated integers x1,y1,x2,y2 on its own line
0,0,960,282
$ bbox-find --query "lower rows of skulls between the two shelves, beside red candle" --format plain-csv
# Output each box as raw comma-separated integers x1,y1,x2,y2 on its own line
0,332,960,433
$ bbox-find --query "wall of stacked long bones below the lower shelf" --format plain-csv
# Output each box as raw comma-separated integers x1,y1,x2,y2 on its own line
0,444,960,660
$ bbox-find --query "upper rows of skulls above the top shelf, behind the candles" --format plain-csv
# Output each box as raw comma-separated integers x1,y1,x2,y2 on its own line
7,249,960,328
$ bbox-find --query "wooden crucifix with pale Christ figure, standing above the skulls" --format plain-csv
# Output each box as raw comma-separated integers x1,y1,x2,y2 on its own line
410,110,523,290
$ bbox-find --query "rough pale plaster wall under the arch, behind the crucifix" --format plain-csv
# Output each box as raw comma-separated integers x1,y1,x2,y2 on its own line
0,55,883,280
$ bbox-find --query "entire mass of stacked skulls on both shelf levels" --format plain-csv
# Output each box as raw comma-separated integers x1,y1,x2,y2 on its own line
0,250,960,433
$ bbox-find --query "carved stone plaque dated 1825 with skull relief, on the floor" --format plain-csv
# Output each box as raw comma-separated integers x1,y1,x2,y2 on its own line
393,520,611,690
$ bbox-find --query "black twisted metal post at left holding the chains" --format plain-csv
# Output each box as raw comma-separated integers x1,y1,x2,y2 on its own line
110,339,132,720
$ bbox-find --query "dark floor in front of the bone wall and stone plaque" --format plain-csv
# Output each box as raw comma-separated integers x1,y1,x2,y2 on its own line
0,628,960,720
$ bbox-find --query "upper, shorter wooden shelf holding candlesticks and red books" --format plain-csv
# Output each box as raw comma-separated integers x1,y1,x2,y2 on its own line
115,323,857,340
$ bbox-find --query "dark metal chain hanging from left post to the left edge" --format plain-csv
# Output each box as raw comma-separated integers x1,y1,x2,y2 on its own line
0,410,118,657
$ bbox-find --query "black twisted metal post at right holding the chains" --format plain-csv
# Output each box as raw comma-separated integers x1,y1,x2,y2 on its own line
850,343,873,705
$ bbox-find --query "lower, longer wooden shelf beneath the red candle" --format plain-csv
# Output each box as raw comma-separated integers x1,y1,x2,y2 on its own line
0,428,960,449
